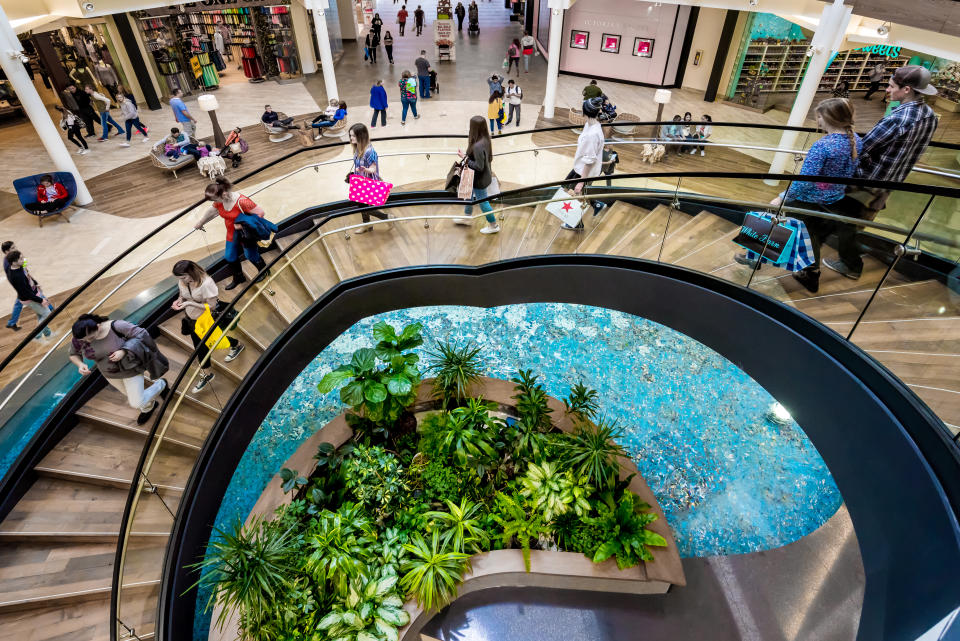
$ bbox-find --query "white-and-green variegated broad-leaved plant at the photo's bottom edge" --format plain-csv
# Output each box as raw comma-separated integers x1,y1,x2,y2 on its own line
317,568,410,641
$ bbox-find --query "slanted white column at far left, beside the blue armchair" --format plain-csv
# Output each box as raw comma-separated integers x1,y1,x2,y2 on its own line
0,7,93,205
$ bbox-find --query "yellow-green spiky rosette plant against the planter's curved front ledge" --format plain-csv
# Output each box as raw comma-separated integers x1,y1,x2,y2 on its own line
400,530,470,610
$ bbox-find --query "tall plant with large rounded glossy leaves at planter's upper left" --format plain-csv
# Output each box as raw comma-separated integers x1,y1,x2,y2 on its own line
317,321,423,426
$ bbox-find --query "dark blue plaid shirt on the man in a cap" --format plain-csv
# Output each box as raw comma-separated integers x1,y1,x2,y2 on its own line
857,100,937,182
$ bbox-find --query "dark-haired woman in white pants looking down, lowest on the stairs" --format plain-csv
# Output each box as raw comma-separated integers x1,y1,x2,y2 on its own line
69,314,170,425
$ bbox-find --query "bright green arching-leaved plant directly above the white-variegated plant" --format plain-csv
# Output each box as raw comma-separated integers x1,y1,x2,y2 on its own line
306,503,376,595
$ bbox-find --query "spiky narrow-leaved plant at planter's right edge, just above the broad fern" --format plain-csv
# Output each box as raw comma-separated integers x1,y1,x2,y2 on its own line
560,418,627,487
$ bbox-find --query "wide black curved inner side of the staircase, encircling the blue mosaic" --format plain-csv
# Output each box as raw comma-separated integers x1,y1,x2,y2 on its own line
157,255,960,641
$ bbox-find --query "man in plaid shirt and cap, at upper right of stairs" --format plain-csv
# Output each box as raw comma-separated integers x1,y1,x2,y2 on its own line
823,65,937,280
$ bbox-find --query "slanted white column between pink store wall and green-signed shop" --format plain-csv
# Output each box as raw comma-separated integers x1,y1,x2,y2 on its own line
764,0,852,185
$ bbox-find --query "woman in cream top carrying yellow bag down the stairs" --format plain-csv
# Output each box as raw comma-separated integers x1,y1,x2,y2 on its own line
171,260,244,394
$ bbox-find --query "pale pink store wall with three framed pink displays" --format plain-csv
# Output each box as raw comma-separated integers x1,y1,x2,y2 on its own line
560,0,690,86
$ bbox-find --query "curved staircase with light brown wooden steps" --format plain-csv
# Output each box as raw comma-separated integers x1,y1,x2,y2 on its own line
0,195,960,641
